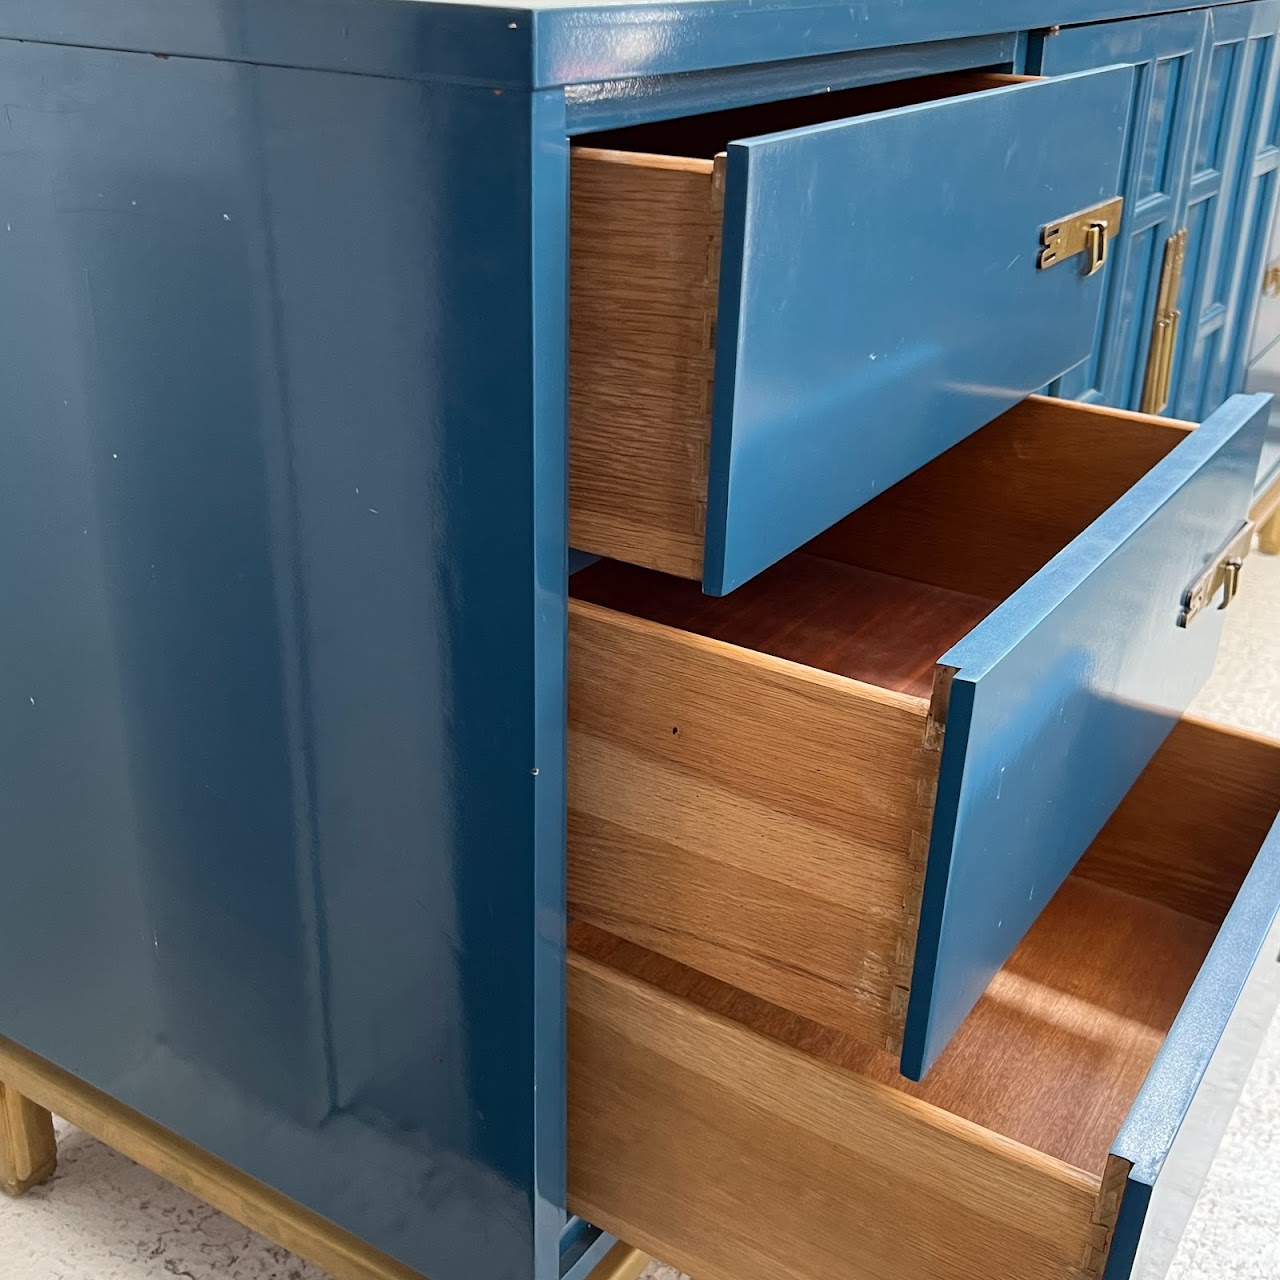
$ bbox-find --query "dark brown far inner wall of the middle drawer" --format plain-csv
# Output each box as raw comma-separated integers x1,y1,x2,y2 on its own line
805,396,1192,600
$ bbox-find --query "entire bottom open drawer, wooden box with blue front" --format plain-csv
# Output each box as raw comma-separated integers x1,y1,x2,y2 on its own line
568,722,1280,1280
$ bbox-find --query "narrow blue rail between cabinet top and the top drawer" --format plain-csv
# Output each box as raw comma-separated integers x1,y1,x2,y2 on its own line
564,35,1018,133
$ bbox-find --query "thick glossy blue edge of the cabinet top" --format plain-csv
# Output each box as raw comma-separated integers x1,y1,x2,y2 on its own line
0,0,1244,88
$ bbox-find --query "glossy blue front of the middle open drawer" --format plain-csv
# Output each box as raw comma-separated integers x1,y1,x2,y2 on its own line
902,396,1271,1079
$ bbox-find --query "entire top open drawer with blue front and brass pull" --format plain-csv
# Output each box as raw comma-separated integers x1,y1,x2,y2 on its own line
570,67,1133,595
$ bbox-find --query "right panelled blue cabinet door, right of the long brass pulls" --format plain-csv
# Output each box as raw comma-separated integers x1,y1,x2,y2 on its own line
1169,0,1280,421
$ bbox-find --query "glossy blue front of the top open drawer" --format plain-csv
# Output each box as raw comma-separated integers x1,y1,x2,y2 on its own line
703,68,1133,595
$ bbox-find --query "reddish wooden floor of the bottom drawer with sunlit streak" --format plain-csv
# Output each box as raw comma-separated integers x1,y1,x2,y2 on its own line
570,860,1215,1176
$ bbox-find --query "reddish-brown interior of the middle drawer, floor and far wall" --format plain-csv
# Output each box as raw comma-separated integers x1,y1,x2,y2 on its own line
571,397,1189,703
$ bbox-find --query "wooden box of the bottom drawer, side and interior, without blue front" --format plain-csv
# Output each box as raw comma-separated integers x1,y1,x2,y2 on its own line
570,722,1280,1280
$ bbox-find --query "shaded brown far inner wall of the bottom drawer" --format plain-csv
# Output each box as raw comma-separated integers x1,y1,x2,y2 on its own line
1076,718,1280,925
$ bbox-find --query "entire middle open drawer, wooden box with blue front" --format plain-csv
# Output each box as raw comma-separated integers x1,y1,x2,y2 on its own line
568,397,1270,1079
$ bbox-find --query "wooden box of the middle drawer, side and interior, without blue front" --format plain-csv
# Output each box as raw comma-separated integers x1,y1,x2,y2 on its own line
568,399,1187,1052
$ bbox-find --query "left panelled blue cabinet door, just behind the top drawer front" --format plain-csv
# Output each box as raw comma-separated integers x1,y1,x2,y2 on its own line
1032,10,1208,408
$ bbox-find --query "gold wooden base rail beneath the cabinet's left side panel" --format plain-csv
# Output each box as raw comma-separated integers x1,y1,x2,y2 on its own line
0,1037,422,1280
